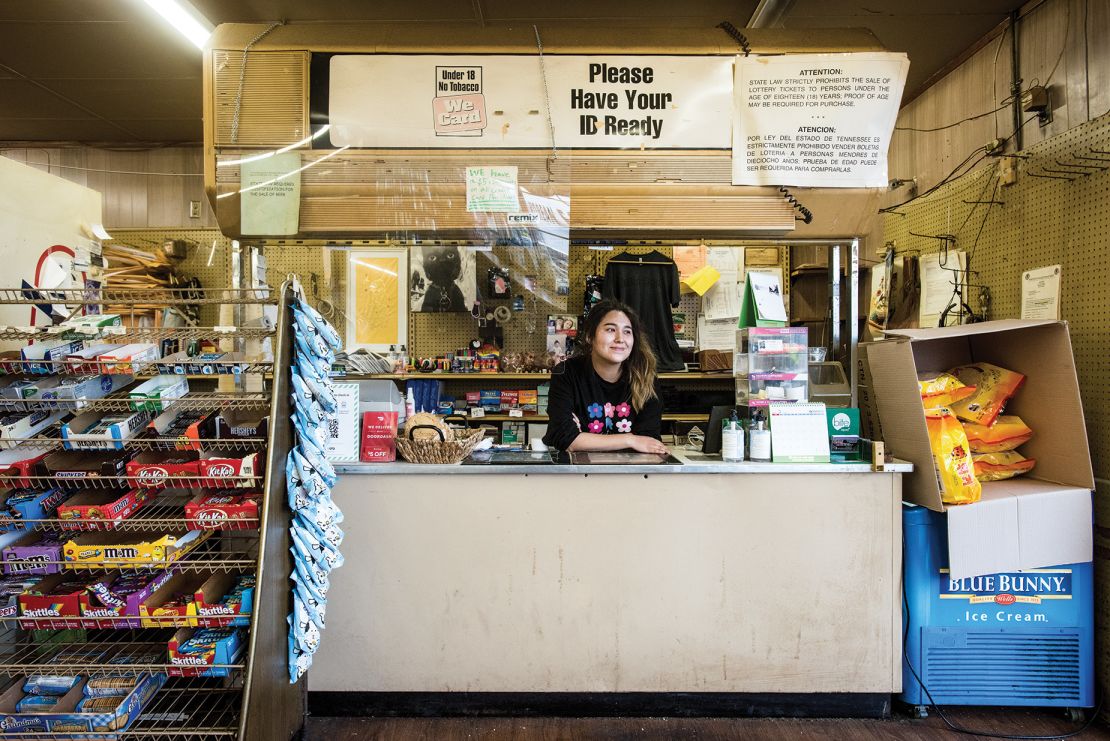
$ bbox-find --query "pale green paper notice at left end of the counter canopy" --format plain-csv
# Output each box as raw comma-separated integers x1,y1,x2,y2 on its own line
239,152,301,236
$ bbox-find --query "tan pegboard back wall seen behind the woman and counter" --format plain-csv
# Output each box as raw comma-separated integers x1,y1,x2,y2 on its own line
254,240,789,357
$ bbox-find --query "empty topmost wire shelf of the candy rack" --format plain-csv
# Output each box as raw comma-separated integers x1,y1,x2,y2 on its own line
0,287,278,306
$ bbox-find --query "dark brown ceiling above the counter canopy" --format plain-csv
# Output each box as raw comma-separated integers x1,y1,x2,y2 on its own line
0,0,1022,144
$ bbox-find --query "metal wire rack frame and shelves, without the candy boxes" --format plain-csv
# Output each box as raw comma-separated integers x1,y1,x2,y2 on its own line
0,285,305,741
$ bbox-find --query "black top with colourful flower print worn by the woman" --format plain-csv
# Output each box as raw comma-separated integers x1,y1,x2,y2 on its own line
544,355,663,450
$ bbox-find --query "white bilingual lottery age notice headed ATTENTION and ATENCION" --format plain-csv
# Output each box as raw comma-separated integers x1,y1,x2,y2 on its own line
733,52,909,187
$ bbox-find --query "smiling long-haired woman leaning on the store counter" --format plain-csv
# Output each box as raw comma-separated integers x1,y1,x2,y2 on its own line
544,300,667,455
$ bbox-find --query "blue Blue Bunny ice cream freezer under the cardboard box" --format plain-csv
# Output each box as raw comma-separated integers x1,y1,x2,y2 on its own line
898,506,1094,708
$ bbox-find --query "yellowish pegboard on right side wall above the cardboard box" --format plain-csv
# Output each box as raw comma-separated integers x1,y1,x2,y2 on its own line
874,109,1110,479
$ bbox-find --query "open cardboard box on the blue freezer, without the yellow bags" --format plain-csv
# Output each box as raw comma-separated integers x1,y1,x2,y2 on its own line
867,319,1094,578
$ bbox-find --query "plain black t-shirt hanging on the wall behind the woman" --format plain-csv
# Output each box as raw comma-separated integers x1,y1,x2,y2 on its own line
604,252,686,371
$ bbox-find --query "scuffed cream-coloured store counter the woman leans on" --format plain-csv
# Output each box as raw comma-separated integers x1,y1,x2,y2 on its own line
310,449,911,702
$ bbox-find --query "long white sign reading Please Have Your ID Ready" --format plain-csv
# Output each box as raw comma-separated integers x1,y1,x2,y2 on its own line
329,54,734,150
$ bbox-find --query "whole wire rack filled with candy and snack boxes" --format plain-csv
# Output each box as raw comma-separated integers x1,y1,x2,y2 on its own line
0,287,304,741
